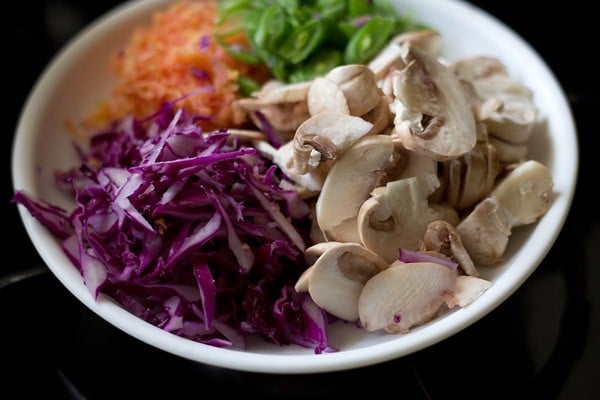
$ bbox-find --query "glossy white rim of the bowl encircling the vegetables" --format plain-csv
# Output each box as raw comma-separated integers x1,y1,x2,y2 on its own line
11,0,579,374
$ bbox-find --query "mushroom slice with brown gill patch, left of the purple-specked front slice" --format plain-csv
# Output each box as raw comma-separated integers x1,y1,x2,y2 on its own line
308,243,389,321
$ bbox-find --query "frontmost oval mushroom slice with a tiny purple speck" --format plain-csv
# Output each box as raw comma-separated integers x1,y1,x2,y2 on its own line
358,261,457,333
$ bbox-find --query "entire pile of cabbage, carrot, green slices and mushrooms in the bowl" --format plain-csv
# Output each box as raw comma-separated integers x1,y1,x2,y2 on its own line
14,0,553,353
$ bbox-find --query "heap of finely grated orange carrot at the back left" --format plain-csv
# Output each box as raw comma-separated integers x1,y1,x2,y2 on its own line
86,0,265,129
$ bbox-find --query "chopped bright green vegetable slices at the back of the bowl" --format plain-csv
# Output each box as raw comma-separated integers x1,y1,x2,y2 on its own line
216,0,424,82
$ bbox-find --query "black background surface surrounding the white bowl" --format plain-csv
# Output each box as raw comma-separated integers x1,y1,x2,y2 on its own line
0,0,600,400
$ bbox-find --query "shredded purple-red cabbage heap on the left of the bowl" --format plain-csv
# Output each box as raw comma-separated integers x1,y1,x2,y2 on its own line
13,104,337,353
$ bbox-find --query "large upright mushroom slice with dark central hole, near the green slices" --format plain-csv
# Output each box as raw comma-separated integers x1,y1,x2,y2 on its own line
392,47,477,161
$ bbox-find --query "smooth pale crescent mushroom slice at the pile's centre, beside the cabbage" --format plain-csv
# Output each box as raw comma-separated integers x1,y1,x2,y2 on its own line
316,135,394,243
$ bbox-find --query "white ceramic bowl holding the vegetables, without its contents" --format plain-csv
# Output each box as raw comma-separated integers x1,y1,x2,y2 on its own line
12,0,578,374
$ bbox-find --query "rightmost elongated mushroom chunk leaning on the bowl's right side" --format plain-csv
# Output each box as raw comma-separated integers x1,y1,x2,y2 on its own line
456,160,553,265
